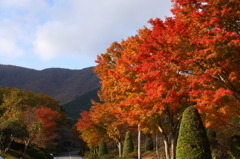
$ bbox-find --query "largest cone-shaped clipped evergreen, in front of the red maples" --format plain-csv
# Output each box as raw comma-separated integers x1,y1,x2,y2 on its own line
176,106,212,159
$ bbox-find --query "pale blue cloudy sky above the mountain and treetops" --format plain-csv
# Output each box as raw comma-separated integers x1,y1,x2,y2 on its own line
0,0,171,70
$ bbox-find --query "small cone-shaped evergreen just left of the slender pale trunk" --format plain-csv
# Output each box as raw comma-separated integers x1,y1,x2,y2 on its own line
123,131,134,157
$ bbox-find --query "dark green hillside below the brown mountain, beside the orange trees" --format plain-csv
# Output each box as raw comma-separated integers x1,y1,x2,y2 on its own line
63,88,100,119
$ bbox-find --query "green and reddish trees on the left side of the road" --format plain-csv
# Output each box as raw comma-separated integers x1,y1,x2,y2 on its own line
0,87,66,156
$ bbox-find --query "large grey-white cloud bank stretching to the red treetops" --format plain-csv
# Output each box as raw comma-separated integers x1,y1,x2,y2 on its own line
34,0,170,59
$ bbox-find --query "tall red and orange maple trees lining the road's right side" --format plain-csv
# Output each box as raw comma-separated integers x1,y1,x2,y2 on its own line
76,0,240,159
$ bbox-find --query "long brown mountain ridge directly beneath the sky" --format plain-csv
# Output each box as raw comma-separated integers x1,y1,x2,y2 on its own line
0,65,100,104
